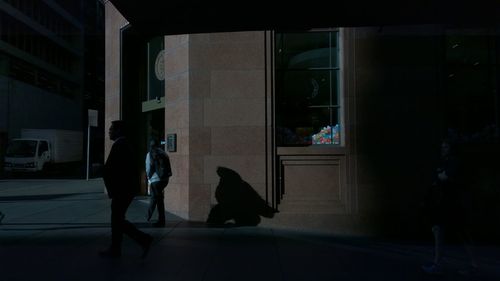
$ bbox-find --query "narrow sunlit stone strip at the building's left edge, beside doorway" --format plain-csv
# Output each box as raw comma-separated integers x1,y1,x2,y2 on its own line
104,1,127,159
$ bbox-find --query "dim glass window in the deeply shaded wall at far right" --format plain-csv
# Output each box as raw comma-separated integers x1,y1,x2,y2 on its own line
444,28,499,135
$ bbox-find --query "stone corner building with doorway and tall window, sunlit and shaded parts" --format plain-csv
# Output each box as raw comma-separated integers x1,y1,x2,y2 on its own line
105,1,500,239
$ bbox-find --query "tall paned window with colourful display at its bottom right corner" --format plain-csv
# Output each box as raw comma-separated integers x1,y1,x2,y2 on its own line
276,31,341,146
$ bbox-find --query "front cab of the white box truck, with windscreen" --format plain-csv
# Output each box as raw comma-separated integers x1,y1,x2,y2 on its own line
4,139,51,172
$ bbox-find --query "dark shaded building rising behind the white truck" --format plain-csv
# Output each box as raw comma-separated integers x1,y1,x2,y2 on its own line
0,0,104,176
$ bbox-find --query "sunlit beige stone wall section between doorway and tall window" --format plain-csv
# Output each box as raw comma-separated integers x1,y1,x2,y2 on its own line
165,32,266,221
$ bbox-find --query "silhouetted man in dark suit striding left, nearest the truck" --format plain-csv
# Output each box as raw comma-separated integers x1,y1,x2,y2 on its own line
99,120,153,258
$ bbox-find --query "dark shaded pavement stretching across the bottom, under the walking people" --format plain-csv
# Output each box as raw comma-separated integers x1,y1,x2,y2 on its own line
0,179,500,281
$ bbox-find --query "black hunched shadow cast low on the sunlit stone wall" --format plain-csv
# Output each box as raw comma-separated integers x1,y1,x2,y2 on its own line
207,167,276,226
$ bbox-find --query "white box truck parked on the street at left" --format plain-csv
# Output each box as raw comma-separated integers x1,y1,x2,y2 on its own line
4,129,83,172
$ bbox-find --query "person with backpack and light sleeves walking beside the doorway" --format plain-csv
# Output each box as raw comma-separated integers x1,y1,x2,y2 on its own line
146,139,172,227
